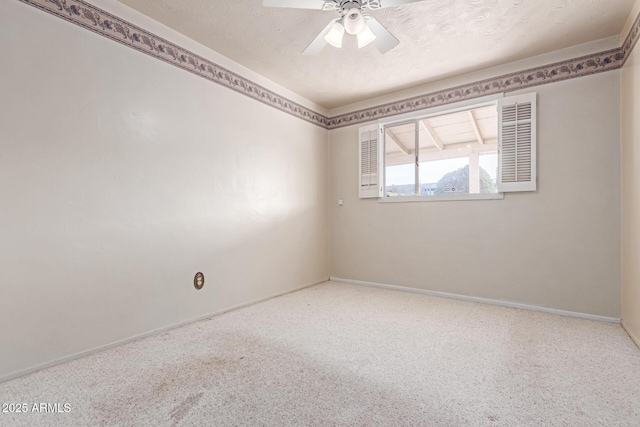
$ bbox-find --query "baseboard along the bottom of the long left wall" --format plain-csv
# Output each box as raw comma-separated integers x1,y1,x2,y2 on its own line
0,279,329,383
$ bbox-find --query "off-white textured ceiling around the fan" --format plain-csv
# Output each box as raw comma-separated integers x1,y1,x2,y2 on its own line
119,0,634,109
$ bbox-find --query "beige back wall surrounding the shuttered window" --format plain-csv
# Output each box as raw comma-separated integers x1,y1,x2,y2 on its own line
330,71,621,318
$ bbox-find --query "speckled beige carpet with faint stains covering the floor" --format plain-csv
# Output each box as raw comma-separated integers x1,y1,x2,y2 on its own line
0,282,640,427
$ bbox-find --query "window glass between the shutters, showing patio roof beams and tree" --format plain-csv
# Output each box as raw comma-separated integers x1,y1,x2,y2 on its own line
384,104,498,197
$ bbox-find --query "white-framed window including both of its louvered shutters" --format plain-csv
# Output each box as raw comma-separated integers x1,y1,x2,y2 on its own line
360,94,536,200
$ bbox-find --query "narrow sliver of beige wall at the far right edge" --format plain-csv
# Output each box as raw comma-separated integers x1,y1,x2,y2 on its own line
621,30,640,345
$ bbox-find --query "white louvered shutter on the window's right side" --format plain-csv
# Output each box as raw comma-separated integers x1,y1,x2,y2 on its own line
498,93,536,192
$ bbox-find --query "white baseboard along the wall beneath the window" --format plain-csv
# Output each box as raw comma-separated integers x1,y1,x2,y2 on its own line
329,277,620,323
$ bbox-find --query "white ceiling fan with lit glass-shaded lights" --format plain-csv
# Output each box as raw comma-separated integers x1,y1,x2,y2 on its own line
263,0,420,55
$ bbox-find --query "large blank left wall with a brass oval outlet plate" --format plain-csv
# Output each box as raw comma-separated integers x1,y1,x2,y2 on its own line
0,1,329,378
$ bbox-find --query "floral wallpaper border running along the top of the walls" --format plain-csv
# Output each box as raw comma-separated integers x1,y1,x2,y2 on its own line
13,0,640,129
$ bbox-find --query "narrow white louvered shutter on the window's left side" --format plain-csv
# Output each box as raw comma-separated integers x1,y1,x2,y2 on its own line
358,124,382,199
